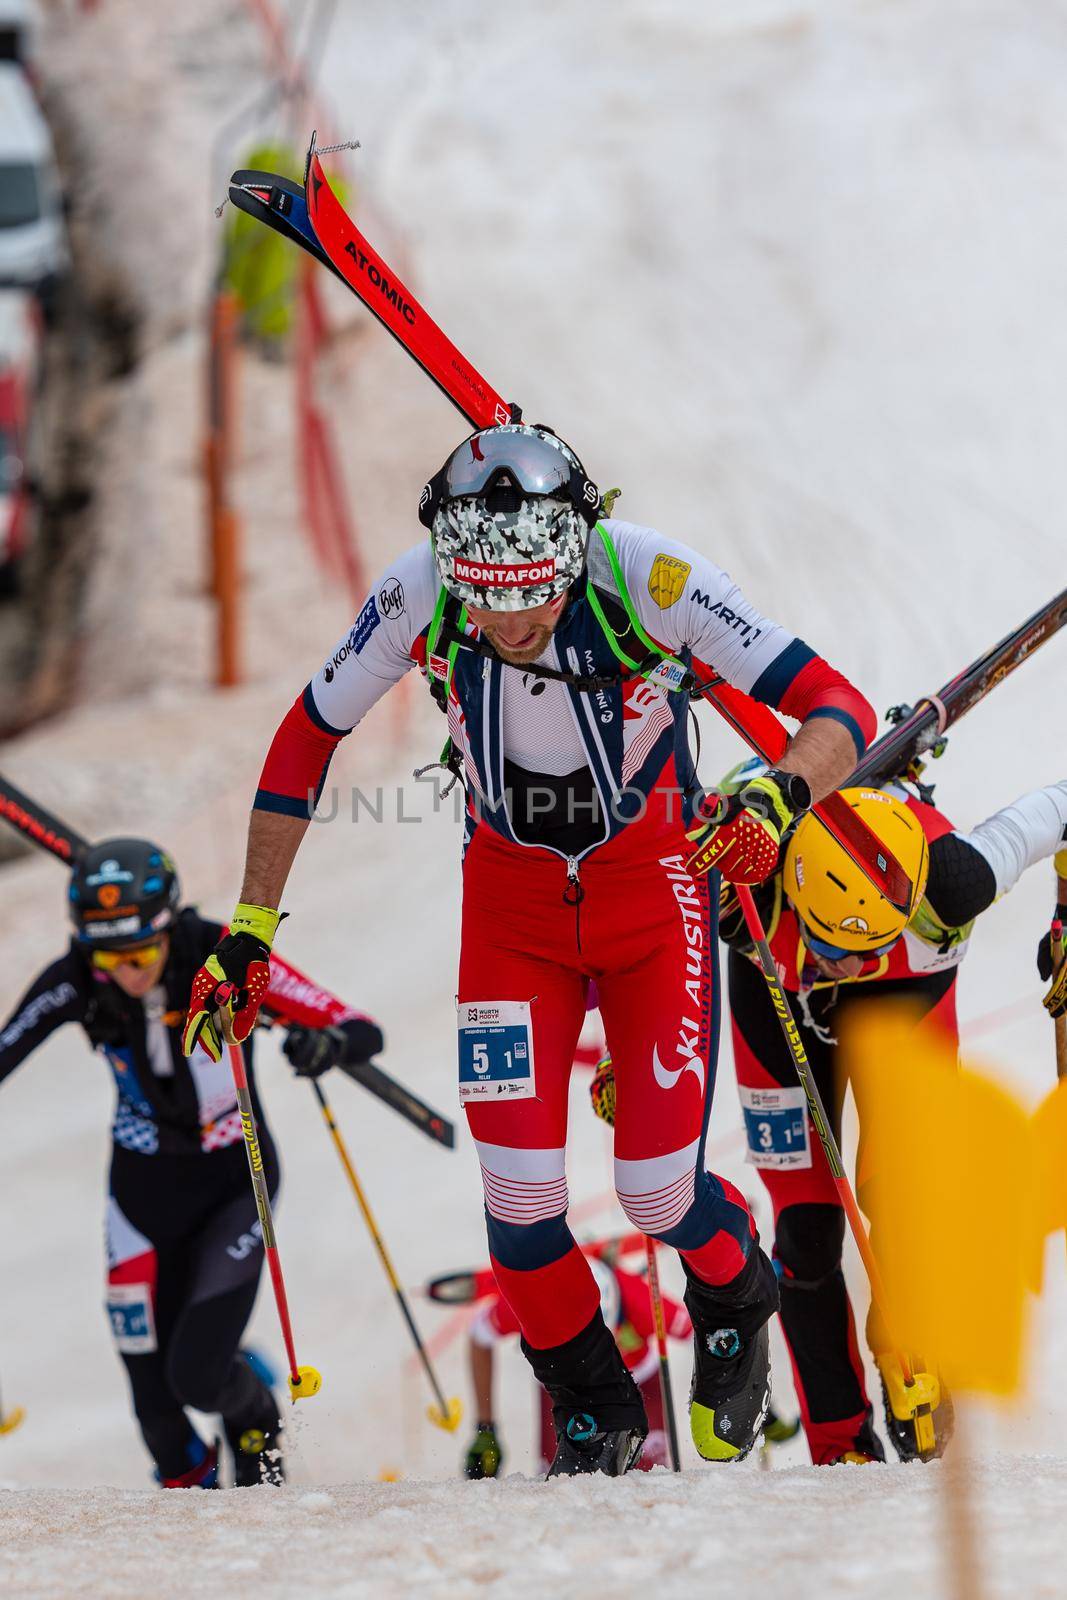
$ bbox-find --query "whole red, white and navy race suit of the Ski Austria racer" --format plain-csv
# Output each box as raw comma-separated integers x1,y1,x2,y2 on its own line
256,520,875,1350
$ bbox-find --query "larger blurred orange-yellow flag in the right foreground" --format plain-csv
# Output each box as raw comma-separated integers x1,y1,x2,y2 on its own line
843,1003,1033,1395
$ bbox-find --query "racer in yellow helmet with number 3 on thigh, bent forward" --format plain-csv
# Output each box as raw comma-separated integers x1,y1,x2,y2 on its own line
720,774,1067,1466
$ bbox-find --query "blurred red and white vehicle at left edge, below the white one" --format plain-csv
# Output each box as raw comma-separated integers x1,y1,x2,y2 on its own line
0,290,42,598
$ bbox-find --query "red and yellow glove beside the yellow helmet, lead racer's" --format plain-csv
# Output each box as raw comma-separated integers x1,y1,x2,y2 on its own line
686,768,811,883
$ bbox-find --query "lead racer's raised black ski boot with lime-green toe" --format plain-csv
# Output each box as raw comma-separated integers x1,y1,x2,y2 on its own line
685,1245,777,1461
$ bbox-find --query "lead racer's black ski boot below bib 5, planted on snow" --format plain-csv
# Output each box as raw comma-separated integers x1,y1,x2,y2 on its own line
523,1310,648,1478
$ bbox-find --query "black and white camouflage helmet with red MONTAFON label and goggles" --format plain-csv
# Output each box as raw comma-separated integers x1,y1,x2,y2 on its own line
419,422,600,611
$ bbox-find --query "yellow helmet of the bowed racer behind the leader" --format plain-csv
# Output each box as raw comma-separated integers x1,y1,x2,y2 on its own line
782,789,929,955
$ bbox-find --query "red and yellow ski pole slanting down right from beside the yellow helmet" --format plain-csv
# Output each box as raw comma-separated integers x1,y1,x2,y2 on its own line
734,883,936,1456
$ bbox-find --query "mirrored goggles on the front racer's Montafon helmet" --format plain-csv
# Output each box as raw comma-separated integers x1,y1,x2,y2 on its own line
419,422,600,530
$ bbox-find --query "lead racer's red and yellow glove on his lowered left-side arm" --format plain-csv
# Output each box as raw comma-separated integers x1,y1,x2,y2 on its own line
181,904,282,1061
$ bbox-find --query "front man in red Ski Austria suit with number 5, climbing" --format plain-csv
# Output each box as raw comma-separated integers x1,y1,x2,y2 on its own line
187,424,875,1474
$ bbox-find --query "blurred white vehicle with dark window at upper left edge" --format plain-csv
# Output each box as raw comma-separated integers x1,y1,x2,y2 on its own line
0,62,70,312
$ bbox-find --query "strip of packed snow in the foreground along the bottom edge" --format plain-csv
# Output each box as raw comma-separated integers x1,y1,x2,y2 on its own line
8,1456,1067,1600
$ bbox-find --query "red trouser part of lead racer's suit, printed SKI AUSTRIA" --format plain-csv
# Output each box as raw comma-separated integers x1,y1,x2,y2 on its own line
459,787,755,1349
